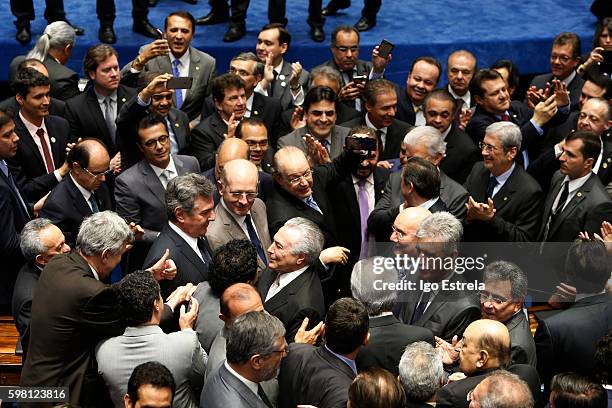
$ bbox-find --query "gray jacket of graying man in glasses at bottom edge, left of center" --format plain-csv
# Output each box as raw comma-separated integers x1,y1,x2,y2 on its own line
200,364,268,408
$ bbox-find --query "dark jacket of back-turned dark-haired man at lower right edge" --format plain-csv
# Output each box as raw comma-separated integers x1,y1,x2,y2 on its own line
534,293,612,388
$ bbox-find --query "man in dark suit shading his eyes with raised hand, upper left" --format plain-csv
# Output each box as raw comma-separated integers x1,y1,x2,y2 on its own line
115,72,191,170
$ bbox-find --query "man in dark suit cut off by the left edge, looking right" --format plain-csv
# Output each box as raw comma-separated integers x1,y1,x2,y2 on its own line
0,111,32,312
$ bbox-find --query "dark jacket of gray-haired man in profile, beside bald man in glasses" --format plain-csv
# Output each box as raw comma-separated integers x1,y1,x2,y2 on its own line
144,225,212,299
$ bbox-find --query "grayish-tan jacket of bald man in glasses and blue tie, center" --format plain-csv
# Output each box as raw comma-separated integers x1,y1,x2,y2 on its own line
206,198,271,270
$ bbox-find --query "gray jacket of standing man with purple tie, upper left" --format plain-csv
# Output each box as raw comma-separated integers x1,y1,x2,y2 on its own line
121,47,216,120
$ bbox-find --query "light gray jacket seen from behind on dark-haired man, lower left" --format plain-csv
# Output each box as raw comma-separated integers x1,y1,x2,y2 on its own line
96,325,208,408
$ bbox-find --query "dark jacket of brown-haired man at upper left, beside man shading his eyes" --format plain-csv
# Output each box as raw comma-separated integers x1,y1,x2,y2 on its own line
66,85,136,157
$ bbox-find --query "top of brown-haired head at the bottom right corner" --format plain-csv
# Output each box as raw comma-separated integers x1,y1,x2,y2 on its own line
550,373,608,408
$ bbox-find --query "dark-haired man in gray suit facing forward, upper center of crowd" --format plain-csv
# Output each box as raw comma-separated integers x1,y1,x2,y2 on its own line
278,86,350,160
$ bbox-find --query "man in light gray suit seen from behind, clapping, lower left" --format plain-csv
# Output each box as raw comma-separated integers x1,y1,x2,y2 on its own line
96,271,208,408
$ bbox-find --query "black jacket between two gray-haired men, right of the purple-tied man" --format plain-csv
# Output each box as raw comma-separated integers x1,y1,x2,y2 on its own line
440,125,482,184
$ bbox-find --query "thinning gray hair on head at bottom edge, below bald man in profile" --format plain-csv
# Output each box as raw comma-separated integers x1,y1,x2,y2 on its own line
480,370,534,408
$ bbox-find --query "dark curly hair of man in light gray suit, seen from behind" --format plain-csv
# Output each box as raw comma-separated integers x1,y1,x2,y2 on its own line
116,271,160,327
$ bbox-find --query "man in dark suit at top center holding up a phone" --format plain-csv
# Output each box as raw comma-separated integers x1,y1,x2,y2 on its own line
319,26,391,112
